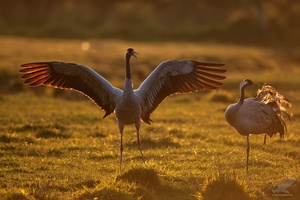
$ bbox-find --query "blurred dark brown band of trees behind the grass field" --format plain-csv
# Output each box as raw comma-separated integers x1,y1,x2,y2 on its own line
0,0,300,46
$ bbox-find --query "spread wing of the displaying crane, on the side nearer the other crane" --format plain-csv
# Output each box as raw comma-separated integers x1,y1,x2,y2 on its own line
135,60,227,124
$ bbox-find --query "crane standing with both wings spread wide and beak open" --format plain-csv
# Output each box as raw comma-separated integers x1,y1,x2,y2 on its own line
20,48,226,171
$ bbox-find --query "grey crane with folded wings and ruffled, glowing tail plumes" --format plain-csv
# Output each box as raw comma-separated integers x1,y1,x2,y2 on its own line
225,79,291,171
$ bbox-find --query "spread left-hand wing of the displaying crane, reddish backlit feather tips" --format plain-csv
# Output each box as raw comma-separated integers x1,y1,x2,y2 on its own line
20,62,122,117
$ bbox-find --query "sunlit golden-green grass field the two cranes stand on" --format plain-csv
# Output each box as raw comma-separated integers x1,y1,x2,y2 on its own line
0,37,300,200
